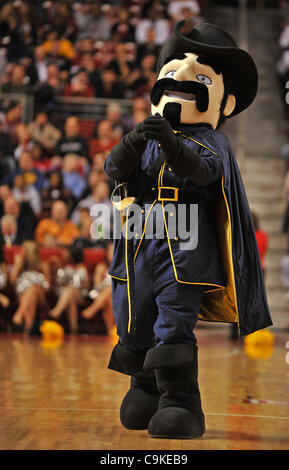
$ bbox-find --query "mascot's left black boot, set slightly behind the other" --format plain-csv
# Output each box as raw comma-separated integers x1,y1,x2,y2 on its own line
108,344,160,430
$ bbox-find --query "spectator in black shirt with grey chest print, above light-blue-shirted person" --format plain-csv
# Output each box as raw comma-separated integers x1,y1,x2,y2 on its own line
54,116,88,161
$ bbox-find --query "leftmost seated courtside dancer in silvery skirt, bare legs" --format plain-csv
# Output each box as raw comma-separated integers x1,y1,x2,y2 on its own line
10,240,50,333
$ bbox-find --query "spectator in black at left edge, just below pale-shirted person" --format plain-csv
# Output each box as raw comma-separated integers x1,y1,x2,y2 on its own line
2,196,36,241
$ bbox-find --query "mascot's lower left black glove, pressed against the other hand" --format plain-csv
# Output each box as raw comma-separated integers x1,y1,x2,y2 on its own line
110,121,148,173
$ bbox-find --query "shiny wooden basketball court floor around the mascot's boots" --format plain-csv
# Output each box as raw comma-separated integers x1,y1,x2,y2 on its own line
0,328,289,451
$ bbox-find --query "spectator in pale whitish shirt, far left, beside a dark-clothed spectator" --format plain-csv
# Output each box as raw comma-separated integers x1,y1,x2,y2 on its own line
12,173,42,218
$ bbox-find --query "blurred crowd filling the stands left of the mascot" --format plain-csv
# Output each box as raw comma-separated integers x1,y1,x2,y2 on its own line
0,0,204,333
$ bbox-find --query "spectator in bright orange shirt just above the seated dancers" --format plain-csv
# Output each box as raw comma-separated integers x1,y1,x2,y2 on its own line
35,201,79,246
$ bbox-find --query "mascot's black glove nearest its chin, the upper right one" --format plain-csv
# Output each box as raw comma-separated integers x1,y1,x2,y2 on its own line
143,114,177,163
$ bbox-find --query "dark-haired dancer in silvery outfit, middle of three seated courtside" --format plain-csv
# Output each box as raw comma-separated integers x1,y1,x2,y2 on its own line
49,246,89,333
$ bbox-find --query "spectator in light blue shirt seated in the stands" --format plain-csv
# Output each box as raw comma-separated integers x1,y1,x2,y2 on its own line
62,153,86,199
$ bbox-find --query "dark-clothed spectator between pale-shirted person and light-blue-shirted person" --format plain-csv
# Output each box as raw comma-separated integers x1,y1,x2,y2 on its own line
41,171,75,217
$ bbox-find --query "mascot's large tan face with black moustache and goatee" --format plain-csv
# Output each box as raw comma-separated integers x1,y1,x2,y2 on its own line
151,52,236,129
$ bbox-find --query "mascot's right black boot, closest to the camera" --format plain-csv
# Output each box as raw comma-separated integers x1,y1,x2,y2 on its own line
145,344,205,439
